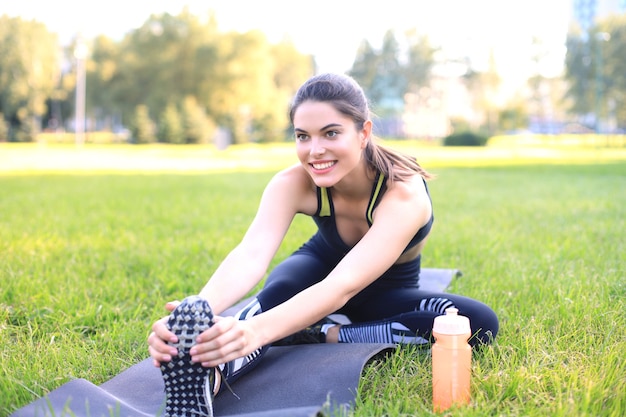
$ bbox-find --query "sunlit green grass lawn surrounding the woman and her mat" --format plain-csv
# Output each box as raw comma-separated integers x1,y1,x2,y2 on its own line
0,144,626,417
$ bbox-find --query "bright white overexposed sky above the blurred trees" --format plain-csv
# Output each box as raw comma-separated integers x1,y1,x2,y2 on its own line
0,0,571,91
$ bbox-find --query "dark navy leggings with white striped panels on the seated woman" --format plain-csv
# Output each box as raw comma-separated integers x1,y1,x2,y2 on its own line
257,233,498,345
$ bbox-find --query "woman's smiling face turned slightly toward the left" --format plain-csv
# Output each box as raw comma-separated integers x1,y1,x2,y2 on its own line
293,101,371,187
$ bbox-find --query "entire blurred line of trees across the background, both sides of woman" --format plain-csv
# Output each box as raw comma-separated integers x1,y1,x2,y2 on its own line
0,10,626,145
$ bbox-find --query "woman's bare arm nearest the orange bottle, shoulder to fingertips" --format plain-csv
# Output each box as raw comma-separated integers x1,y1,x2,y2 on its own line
193,177,431,366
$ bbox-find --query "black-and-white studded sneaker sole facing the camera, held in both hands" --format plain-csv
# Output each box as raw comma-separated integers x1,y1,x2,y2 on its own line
160,296,220,417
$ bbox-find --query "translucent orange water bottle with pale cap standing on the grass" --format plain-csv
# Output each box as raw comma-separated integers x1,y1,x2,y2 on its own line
431,307,472,412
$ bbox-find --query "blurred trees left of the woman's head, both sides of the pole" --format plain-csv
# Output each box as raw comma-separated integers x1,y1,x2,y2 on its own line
0,11,314,143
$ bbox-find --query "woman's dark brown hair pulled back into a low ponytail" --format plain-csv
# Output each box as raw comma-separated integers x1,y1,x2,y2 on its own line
289,73,432,181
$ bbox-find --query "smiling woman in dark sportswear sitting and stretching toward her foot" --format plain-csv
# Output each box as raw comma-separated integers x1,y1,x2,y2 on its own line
149,74,498,414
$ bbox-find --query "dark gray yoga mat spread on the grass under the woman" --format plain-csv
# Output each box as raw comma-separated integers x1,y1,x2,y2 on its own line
11,268,461,417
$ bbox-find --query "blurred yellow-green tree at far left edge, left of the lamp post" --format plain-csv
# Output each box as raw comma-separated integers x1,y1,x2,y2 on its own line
0,15,60,141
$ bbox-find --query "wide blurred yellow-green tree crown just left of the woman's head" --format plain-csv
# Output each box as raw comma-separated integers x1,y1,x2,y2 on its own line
80,10,313,142
